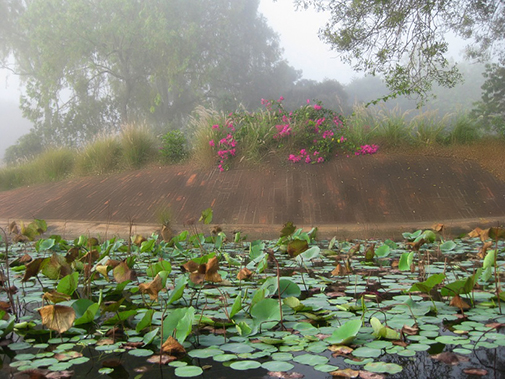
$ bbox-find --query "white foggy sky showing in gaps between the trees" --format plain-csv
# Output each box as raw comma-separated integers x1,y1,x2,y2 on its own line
0,0,483,163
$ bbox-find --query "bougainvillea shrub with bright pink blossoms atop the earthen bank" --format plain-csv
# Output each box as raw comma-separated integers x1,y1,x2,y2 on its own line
208,97,378,171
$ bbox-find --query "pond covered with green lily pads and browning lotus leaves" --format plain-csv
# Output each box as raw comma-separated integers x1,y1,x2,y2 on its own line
0,221,505,378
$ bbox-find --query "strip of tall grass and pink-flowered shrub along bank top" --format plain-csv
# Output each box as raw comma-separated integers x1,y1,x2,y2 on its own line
0,98,505,190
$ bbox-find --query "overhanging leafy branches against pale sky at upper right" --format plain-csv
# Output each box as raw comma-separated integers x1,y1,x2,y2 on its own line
295,0,505,100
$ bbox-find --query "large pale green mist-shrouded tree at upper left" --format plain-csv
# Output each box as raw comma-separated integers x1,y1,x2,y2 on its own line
0,0,300,145
